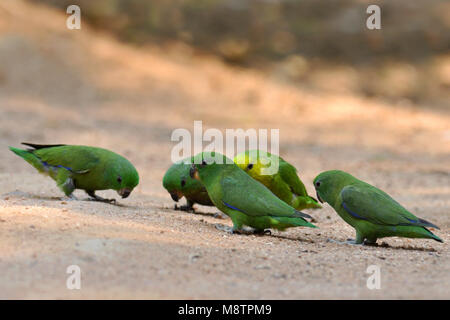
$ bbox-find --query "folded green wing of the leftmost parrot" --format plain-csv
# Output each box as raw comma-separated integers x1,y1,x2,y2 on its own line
33,145,100,174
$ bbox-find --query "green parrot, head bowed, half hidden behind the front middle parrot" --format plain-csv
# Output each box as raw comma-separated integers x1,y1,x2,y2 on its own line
163,157,214,211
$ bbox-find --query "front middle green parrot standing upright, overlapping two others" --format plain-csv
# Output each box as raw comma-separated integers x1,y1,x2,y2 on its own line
190,152,316,233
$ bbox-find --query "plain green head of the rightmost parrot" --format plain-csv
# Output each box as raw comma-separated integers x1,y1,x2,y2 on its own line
314,170,354,205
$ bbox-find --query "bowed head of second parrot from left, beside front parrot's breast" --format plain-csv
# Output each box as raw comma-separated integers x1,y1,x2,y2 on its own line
163,157,194,202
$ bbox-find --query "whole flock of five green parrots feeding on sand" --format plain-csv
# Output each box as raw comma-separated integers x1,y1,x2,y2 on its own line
10,143,443,244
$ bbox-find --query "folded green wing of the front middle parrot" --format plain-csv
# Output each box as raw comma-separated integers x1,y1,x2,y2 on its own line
221,170,311,218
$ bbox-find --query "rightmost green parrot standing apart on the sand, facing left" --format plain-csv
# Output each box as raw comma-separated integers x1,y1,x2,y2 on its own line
314,170,443,244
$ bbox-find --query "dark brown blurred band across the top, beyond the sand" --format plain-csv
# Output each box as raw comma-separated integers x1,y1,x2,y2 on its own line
35,0,450,108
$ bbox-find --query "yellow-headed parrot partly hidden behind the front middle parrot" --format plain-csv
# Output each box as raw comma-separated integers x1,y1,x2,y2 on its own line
234,150,322,210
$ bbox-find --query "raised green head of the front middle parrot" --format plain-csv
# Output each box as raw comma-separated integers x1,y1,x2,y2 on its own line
189,151,235,181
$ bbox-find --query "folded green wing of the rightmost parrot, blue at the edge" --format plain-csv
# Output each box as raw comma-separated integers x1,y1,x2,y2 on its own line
340,185,439,229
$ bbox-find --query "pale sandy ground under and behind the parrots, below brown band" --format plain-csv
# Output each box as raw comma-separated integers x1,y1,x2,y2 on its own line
0,1,450,299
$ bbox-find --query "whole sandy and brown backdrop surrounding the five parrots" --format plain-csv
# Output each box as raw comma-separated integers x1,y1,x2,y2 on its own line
0,0,450,299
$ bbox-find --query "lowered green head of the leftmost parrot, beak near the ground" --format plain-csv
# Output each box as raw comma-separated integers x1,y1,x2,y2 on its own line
105,158,139,198
